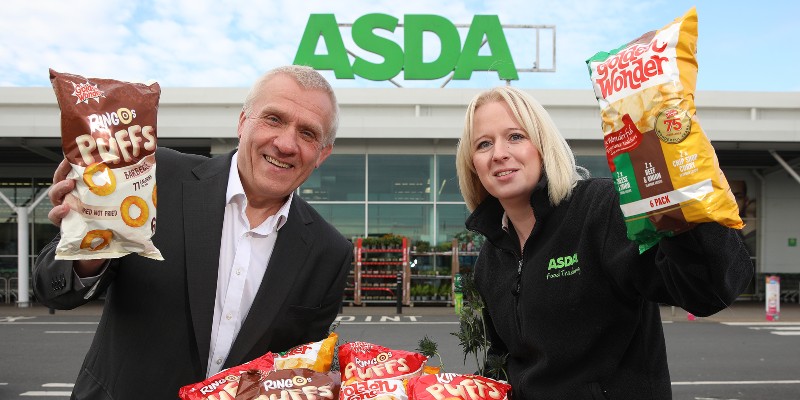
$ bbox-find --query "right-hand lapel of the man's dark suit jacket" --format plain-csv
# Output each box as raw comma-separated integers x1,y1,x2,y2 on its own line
225,195,313,366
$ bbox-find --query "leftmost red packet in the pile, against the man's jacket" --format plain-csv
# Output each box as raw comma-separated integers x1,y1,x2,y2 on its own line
178,353,275,400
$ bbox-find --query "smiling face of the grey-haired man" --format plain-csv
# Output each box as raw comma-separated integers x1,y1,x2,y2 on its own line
237,74,334,206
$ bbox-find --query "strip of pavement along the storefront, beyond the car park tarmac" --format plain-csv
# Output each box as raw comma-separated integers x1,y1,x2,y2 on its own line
0,300,800,323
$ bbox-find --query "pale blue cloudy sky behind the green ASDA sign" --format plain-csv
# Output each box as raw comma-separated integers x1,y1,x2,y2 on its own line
0,0,800,91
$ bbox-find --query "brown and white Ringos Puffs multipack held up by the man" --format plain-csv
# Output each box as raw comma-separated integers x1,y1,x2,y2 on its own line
50,69,163,260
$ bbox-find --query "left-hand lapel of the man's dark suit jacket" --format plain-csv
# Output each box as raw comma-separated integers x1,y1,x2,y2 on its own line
183,154,232,368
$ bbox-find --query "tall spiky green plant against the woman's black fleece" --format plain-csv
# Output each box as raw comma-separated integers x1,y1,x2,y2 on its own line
451,273,508,380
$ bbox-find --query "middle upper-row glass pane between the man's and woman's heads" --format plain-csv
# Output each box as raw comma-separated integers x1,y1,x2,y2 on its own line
367,154,433,201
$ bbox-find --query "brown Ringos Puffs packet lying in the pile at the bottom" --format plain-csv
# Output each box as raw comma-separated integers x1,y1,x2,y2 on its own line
236,368,341,400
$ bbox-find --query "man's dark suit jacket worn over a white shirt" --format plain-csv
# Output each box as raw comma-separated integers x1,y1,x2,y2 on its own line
33,148,353,399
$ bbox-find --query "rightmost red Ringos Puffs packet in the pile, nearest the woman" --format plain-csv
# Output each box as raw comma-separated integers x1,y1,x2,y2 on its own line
408,373,511,400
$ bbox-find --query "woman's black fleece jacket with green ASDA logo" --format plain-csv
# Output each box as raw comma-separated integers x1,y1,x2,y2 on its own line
466,178,754,400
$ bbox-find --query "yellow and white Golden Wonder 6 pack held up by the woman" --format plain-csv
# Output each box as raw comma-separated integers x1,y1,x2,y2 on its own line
586,7,744,252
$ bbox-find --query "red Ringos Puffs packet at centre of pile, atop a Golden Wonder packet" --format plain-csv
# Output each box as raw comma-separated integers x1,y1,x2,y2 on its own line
339,342,428,384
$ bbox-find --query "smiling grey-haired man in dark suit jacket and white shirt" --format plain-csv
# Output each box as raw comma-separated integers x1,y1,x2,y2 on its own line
34,66,352,399
